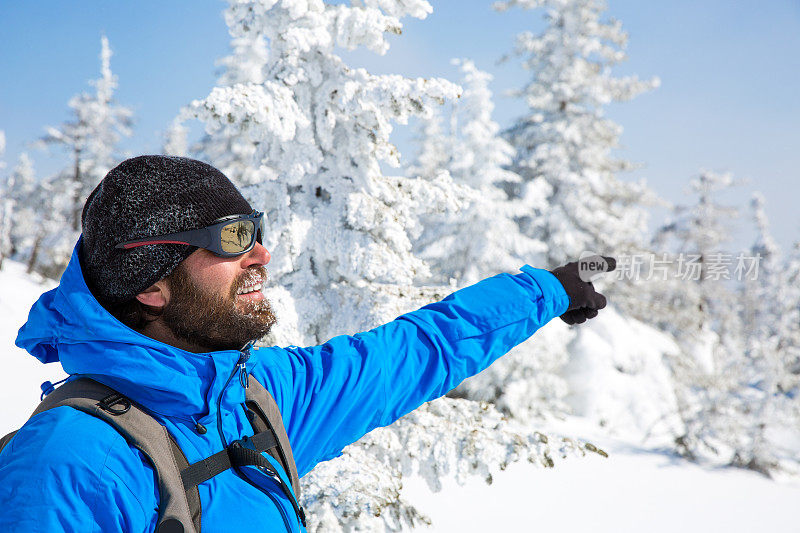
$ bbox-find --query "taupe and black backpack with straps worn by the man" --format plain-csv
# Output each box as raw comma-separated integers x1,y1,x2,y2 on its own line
0,375,306,533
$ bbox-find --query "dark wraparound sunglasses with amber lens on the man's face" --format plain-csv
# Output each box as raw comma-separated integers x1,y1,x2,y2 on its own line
115,211,264,257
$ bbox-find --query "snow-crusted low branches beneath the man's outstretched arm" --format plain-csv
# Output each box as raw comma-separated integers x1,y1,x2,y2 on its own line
302,398,607,532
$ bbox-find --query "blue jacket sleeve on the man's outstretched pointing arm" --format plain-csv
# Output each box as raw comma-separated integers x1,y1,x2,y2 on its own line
253,265,569,476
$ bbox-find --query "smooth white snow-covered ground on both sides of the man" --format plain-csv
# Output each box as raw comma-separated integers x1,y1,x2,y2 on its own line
0,261,800,533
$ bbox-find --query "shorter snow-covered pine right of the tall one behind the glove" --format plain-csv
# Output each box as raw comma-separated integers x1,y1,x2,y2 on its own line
646,171,750,462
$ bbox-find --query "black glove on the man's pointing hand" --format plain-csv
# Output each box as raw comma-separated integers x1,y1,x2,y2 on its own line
550,255,617,326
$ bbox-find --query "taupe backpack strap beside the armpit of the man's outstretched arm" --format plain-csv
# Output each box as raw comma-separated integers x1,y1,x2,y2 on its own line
245,374,300,499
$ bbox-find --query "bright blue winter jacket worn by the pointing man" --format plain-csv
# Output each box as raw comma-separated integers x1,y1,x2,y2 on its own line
0,243,568,533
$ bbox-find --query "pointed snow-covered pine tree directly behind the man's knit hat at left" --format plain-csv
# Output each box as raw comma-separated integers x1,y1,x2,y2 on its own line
37,37,133,274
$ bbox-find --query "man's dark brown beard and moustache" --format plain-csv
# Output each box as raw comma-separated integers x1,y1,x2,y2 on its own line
161,264,277,351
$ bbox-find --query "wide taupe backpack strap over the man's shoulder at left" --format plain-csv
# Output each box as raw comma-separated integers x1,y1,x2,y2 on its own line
4,378,201,533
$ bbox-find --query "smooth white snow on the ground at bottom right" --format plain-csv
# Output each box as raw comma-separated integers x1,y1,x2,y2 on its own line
403,420,800,533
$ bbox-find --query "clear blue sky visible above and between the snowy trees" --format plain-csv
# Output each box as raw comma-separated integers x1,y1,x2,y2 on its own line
0,0,800,254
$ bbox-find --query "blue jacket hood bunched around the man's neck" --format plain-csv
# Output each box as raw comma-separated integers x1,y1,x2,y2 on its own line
16,239,250,423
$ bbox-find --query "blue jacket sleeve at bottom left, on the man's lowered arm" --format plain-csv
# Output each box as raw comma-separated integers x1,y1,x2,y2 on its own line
0,407,158,533
